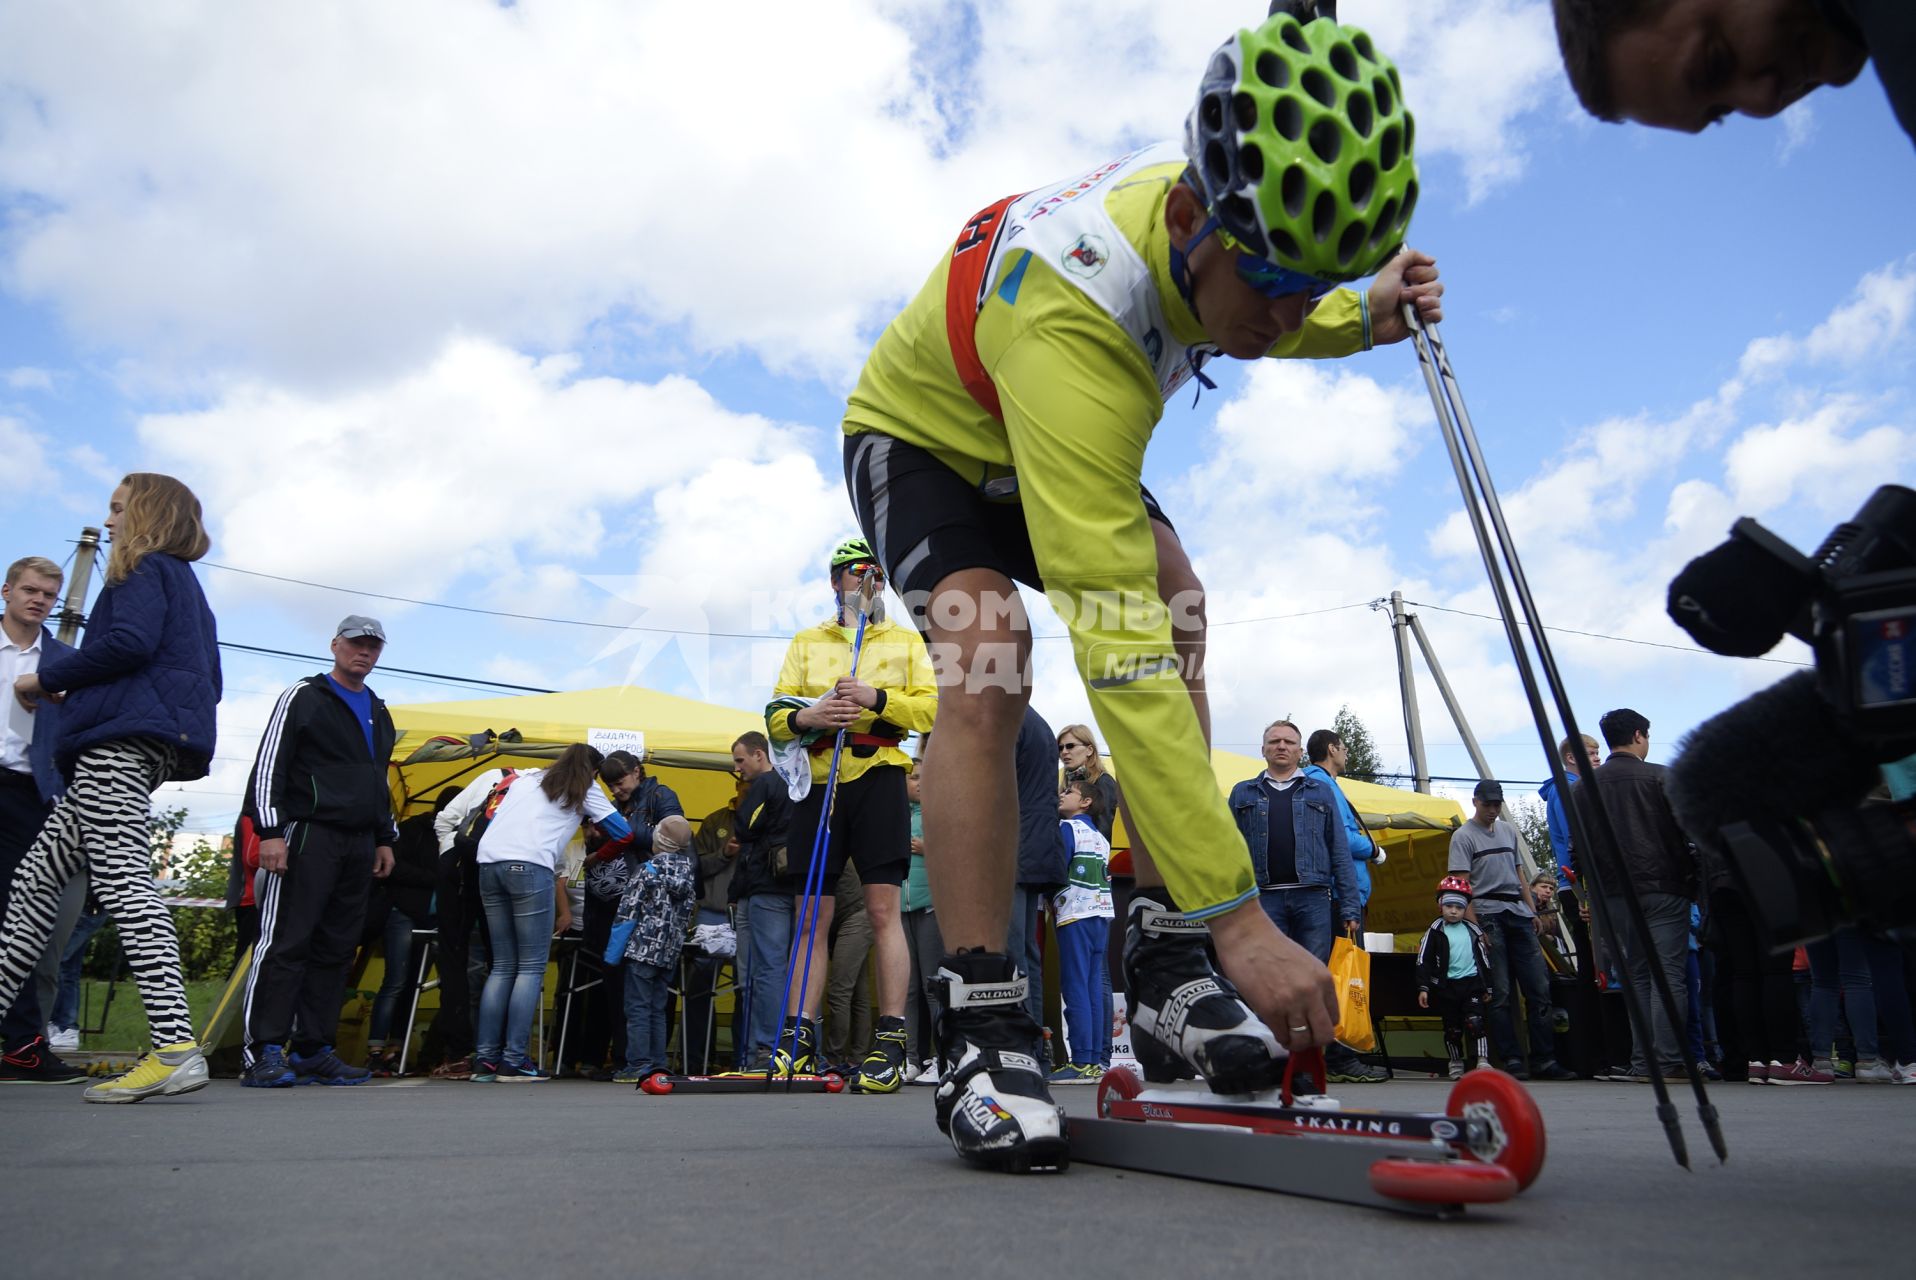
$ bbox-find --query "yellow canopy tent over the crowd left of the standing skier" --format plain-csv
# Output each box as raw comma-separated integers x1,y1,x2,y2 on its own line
391,686,764,822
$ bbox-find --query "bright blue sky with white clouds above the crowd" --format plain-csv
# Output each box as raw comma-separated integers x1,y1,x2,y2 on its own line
0,0,1916,830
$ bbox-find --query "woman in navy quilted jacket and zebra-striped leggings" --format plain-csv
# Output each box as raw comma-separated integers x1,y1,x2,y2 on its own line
0,471,220,1102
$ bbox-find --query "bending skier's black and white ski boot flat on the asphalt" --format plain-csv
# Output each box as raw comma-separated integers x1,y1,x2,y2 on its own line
933,952,1071,1173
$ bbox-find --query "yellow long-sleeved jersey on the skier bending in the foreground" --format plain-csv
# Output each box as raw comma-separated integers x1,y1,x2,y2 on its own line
841,146,1370,918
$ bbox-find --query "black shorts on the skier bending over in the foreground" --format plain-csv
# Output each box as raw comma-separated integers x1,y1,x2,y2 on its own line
845,431,1176,632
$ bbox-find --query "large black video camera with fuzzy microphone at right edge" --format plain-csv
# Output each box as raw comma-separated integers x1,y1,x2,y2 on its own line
1669,485,1916,949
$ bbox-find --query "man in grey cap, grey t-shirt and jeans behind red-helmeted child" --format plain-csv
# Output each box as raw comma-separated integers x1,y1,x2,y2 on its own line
1448,778,1573,1081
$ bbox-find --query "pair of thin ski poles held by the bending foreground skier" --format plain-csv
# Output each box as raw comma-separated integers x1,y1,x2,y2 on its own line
1403,305,1728,1169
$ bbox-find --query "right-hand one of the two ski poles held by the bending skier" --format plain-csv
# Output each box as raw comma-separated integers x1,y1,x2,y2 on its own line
1426,326,1728,1161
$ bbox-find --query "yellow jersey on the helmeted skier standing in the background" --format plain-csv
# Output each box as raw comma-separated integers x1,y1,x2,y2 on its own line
766,619,939,782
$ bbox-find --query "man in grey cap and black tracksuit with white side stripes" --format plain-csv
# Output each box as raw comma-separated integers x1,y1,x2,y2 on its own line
241,613,397,1088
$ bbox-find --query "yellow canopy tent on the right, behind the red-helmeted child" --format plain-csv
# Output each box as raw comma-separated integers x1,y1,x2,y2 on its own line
1106,751,1464,933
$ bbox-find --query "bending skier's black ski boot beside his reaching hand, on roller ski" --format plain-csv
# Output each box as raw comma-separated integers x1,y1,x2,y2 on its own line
1125,891,1286,1094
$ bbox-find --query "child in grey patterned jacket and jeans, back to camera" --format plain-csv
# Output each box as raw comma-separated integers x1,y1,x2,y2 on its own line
613,814,697,1085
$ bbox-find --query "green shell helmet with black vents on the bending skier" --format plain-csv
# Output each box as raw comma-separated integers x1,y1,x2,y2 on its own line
1184,11,1418,282
